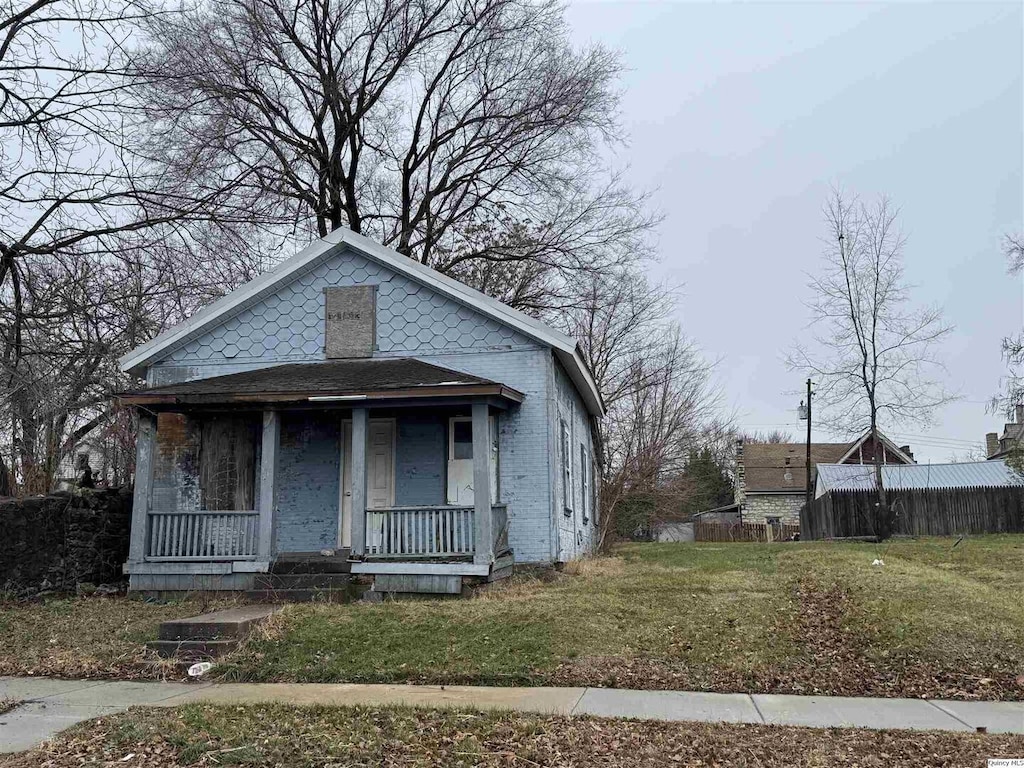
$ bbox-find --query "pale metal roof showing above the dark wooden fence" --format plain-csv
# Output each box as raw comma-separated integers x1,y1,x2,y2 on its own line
817,459,1024,496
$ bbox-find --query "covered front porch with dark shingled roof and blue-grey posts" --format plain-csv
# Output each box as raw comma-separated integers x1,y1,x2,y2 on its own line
124,360,522,591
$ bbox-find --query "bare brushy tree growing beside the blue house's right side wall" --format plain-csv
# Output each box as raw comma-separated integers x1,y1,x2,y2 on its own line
551,269,731,542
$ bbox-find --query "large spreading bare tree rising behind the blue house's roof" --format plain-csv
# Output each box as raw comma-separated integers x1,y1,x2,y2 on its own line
136,0,655,311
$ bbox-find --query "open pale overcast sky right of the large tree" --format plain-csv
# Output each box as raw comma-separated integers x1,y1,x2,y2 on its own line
568,0,1024,462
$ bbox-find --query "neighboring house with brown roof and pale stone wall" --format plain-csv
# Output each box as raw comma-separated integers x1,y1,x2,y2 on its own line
736,431,913,523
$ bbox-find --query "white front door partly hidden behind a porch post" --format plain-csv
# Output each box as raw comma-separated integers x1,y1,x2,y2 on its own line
338,419,395,547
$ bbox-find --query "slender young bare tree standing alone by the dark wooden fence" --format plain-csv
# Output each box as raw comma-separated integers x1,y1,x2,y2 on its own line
787,190,953,538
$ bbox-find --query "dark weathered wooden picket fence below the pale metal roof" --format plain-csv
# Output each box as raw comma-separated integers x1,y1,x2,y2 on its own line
800,487,1024,539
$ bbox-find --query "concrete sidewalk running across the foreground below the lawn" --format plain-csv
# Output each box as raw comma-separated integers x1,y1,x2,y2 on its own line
0,678,1024,753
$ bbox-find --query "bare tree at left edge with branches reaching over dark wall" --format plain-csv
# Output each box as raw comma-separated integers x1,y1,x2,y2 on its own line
0,0,227,493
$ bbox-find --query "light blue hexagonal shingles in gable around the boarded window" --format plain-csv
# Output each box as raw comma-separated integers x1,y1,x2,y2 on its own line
152,247,531,384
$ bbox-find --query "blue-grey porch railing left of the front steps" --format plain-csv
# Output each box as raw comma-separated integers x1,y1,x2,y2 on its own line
145,510,259,561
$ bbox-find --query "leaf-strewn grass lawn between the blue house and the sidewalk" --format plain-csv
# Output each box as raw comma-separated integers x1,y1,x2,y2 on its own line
0,536,1024,699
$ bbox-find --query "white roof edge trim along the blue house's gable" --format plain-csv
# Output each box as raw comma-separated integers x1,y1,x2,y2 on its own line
120,228,604,416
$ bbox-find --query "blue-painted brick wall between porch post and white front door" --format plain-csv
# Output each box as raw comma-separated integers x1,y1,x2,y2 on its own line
275,412,341,552
